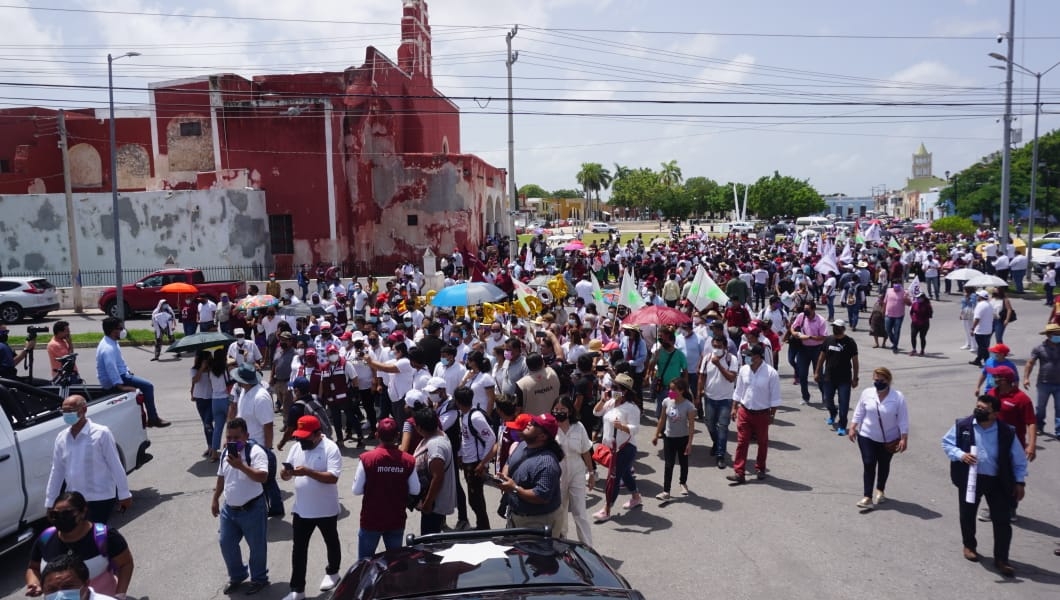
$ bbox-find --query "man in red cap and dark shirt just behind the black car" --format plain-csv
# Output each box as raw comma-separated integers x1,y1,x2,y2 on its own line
499,413,563,531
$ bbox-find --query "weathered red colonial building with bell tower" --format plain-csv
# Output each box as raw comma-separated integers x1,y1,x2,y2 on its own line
0,0,510,277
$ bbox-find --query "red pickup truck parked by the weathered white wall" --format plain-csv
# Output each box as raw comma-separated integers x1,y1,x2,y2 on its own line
100,269,247,317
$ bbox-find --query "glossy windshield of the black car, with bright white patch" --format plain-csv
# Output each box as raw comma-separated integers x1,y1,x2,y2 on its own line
348,539,624,598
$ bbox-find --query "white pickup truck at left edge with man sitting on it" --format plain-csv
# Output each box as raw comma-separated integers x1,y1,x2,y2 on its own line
0,378,151,555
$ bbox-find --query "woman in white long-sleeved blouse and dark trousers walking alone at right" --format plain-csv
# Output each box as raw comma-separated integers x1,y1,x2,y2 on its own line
847,367,909,510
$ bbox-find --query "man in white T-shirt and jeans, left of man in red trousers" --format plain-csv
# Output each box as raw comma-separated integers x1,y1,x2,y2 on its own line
700,337,740,469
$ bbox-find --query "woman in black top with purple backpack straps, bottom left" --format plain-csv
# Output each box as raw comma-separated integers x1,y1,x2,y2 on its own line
25,492,133,600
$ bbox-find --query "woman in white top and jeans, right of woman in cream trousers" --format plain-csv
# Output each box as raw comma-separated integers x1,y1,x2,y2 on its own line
593,373,641,523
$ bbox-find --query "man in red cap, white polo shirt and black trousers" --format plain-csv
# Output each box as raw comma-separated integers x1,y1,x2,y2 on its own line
280,414,342,600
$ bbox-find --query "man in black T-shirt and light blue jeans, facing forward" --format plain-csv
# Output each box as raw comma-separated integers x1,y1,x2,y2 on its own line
813,319,859,436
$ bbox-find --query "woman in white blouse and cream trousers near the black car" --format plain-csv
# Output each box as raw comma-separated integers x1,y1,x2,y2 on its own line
552,395,596,546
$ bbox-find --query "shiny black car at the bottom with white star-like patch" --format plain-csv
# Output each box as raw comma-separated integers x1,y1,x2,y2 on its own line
329,528,644,600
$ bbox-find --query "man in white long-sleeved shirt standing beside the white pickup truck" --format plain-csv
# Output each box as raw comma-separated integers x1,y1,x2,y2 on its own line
45,394,133,524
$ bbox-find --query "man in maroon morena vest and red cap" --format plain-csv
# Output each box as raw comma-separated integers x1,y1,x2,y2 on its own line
353,417,420,560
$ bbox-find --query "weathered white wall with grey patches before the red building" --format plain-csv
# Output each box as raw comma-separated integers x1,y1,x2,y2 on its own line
0,190,271,272
